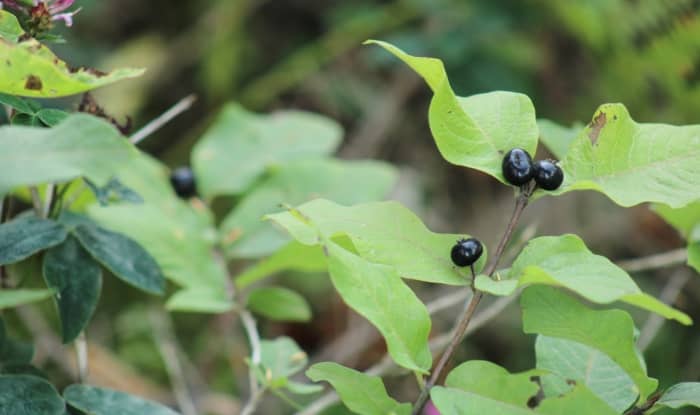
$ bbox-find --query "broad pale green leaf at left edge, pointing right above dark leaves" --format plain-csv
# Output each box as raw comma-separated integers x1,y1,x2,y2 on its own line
0,114,136,193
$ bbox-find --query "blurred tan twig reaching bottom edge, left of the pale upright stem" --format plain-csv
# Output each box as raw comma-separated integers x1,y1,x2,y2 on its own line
149,307,198,415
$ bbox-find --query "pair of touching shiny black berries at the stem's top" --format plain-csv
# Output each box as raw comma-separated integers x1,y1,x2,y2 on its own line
501,148,564,190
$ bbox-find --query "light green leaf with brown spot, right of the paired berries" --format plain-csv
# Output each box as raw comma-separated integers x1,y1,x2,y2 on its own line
538,104,700,207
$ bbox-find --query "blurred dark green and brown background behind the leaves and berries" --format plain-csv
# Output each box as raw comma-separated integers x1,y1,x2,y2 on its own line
10,0,700,413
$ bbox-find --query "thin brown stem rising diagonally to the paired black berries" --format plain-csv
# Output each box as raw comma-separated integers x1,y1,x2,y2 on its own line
412,184,534,415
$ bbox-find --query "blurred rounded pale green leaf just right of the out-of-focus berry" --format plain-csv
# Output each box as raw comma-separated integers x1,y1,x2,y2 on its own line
192,103,342,198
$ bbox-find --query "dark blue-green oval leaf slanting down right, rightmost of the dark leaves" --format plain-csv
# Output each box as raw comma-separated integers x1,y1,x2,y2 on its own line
73,225,165,295
